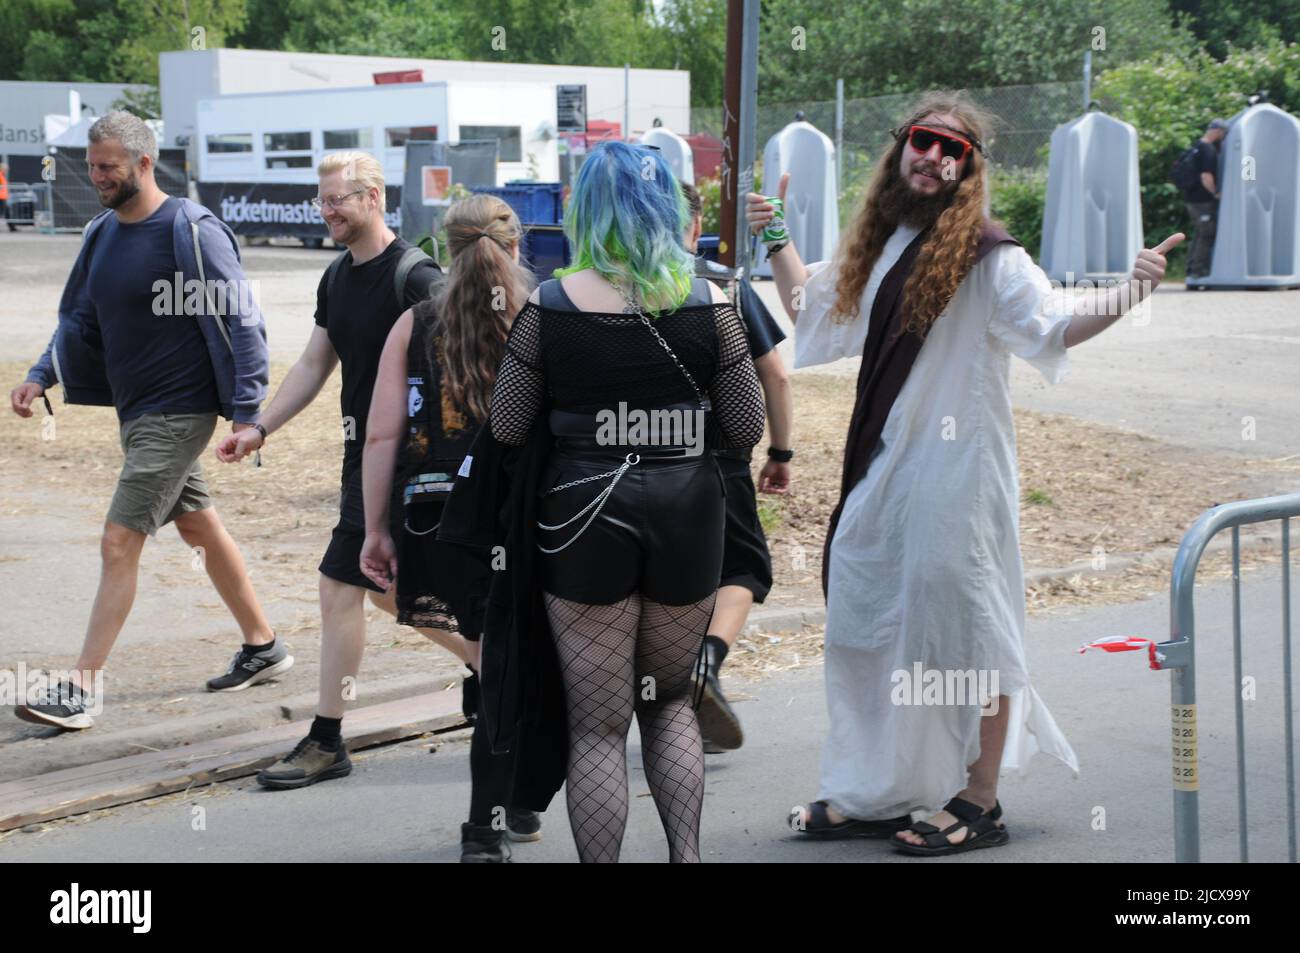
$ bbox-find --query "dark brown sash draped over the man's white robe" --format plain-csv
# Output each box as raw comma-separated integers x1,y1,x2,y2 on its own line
822,220,1019,595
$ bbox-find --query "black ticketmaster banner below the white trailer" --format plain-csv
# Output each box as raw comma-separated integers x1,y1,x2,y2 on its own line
198,182,402,238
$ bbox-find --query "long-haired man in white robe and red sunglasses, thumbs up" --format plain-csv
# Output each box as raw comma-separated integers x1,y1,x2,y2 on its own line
746,96,1182,854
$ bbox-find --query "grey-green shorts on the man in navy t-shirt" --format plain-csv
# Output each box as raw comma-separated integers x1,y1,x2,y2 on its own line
108,413,217,536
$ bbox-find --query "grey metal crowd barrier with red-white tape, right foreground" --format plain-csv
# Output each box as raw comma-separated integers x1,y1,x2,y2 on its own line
1154,493,1300,863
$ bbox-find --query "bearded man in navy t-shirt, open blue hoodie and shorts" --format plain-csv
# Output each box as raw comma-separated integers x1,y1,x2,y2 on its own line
10,112,282,729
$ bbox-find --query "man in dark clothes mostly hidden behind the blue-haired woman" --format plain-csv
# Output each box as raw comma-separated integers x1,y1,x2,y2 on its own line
681,183,794,753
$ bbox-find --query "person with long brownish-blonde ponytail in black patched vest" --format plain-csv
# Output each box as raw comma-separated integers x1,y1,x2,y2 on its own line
361,195,540,863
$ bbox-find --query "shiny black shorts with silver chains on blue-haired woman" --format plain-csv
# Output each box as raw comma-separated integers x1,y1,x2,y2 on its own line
537,452,725,606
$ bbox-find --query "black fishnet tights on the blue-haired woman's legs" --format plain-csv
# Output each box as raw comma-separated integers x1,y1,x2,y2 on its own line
546,593,714,863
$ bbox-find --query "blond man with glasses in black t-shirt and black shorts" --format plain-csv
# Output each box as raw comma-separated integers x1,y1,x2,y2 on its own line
217,152,473,788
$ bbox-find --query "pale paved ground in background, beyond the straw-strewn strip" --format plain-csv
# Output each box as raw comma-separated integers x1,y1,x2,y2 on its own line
0,231,1300,458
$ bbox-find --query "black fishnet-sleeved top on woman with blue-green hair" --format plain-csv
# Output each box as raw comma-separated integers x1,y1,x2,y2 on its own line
491,302,763,450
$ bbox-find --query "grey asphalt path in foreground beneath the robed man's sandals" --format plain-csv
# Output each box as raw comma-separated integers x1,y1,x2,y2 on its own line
0,567,1296,863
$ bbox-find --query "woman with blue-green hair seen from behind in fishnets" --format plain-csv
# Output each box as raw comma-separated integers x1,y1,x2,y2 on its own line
490,142,763,862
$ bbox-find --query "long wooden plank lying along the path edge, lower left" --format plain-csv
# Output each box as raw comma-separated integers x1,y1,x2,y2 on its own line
0,692,464,831
